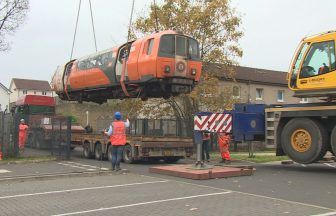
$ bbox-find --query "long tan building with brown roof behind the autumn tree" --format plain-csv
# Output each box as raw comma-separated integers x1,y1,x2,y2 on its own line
209,64,318,104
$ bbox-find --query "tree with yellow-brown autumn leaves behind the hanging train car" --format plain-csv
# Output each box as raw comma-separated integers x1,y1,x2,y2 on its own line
134,0,243,131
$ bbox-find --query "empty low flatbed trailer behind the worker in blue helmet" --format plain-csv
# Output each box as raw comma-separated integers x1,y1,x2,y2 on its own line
71,133,194,163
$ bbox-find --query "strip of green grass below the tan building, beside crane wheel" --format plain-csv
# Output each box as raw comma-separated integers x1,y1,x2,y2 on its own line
210,152,289,163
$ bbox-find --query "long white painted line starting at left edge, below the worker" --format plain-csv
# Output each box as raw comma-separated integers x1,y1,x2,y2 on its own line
0,180,168,200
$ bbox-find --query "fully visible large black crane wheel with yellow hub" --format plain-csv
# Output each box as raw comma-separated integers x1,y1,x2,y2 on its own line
281,118,328,164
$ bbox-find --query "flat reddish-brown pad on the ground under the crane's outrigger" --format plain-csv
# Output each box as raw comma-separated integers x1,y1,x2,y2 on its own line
149,165,255,180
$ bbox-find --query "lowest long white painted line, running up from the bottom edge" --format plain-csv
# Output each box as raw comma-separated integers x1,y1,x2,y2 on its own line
53,191,232,216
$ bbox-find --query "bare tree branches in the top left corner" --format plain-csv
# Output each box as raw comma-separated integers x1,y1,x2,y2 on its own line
0,0,29,51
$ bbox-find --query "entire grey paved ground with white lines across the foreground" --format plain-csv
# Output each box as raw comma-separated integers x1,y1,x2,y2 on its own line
0,150,336,216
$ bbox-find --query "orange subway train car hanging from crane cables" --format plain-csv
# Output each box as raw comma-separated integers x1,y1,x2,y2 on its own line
51,30,202,103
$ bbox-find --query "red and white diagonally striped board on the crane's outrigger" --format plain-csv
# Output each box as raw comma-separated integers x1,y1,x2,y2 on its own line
194,113,232,133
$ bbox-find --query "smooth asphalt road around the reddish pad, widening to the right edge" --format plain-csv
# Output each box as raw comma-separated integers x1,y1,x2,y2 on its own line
69,148,336,209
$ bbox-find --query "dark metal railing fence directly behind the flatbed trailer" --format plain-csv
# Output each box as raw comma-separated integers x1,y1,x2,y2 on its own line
97,116,190,137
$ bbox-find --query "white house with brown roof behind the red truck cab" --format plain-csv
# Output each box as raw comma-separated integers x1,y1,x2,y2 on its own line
9,78,53,105
